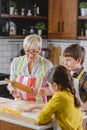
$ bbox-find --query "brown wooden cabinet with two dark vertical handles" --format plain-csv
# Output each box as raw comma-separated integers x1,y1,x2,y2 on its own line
48,0,78,39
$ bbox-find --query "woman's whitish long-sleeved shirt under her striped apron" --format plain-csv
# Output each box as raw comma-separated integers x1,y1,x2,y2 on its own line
10,56,53,80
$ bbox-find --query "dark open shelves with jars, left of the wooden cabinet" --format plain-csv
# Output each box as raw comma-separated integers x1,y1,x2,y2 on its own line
0,0,48,38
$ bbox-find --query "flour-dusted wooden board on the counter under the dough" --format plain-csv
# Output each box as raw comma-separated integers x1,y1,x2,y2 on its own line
0,100,40,125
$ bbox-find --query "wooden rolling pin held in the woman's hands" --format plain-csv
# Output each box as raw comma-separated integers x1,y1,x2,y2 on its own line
4,78,33,93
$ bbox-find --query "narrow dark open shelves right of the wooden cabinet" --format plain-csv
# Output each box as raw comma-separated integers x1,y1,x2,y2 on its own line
77,0,87,40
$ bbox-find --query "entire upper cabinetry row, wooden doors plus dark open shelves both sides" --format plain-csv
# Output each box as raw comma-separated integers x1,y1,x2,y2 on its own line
0,0,87,39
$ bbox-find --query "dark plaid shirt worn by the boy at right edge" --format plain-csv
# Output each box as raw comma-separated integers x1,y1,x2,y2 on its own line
73,67,87,102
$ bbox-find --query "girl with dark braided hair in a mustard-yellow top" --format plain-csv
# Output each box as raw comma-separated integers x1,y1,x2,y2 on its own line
22,65,82,130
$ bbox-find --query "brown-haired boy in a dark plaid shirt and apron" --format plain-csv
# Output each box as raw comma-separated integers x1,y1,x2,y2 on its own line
63,44,87,103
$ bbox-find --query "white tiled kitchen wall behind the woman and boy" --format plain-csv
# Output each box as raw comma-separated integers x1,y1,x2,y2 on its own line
0,39,87,73
